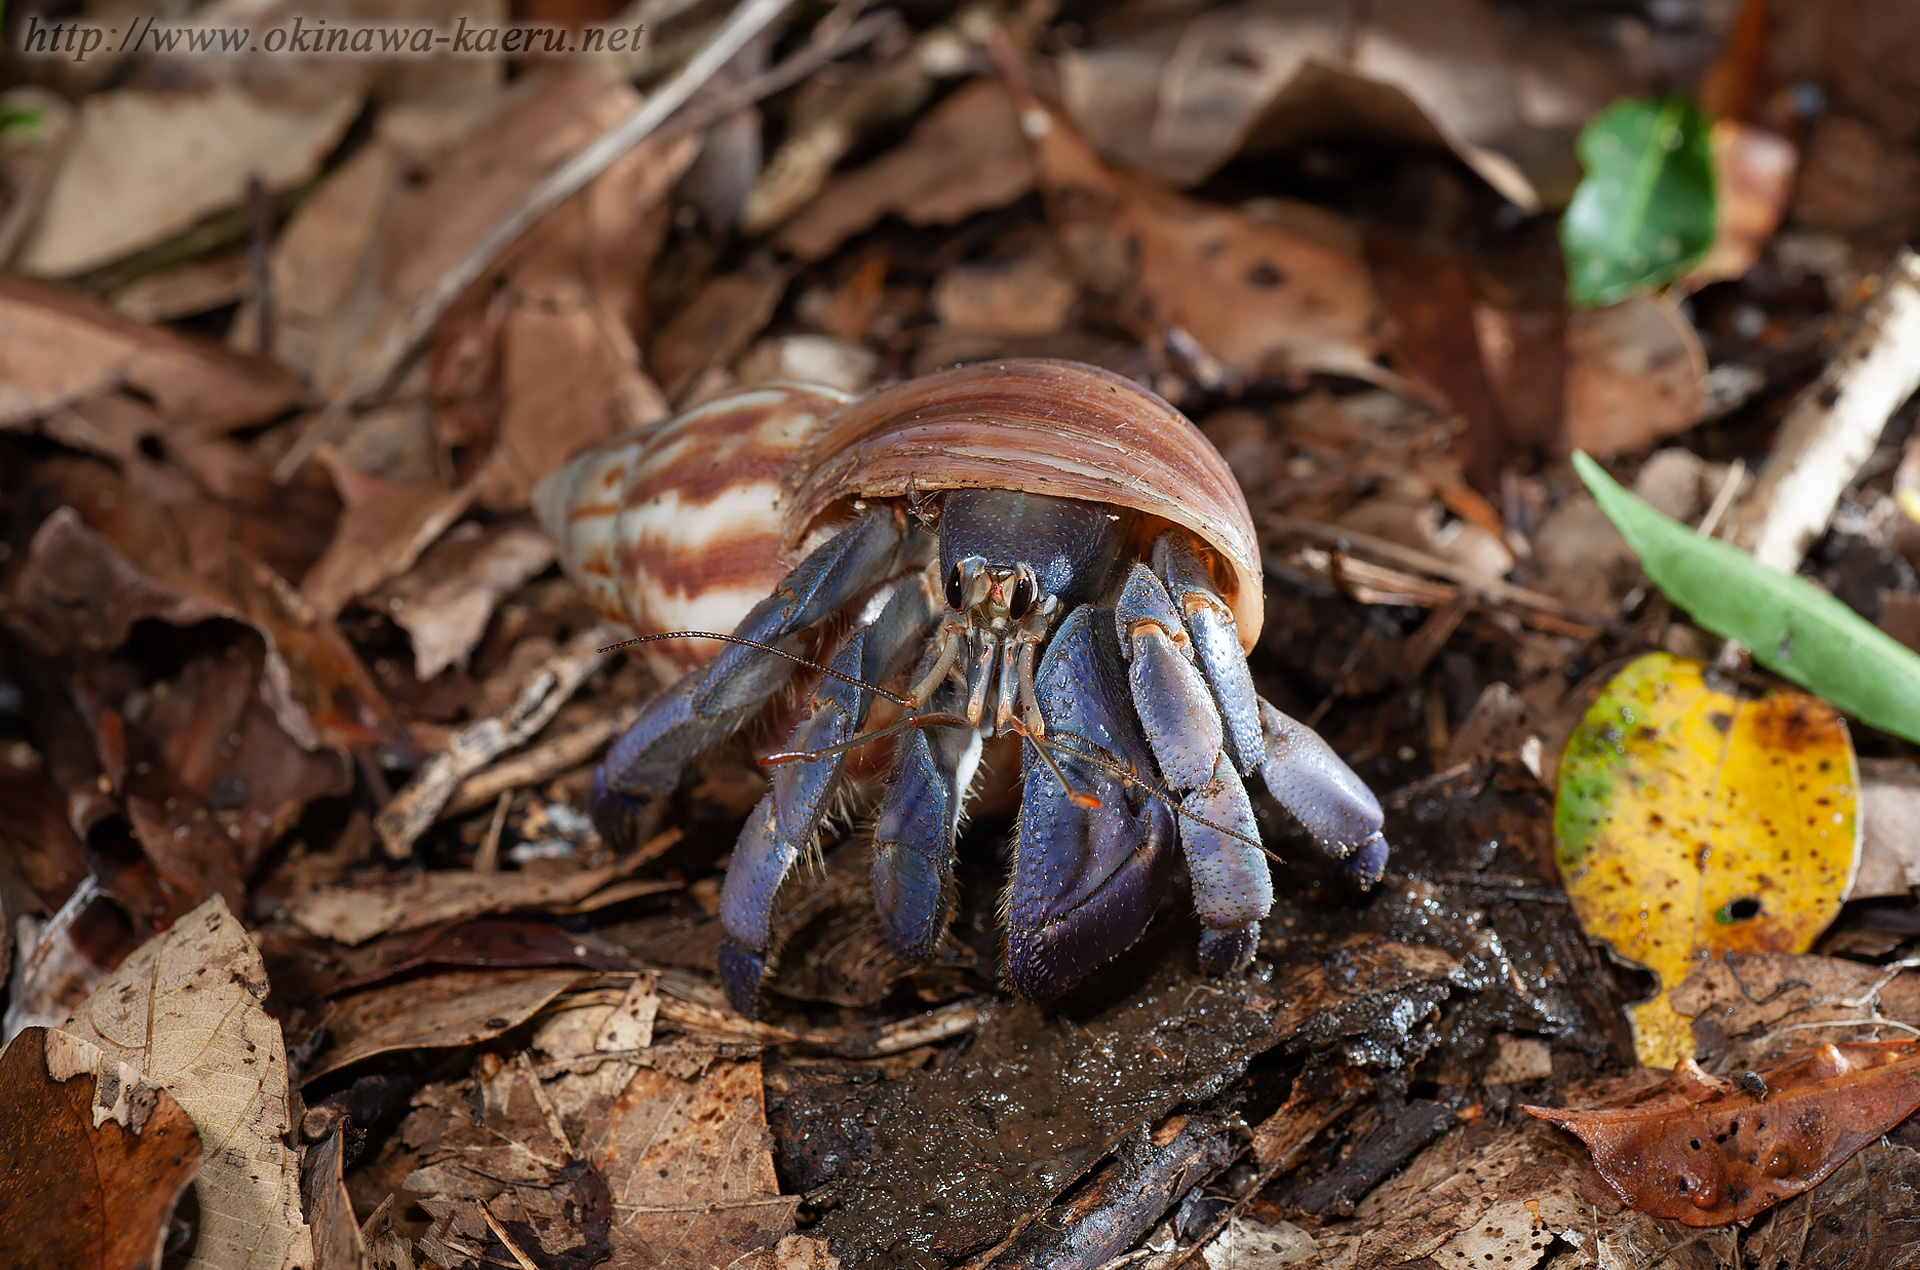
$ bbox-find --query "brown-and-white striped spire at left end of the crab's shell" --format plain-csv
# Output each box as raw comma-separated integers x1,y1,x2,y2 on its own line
534,384,852,682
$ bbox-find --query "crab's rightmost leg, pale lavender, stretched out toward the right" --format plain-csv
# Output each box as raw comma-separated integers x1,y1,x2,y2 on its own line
1154,530,1386,888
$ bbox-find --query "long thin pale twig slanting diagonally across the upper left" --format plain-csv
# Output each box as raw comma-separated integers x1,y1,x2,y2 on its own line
273,0,793,482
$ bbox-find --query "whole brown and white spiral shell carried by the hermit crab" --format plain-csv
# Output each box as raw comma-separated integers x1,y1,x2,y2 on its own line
534,359,1261,680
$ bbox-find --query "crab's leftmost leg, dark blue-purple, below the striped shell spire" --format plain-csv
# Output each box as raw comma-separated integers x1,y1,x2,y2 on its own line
593,507,908,842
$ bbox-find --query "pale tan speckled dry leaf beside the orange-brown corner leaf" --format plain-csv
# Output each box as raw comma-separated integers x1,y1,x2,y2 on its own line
61,895,313,1270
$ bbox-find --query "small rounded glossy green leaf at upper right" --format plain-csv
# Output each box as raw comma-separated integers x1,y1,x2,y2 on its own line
1561,96,1715,307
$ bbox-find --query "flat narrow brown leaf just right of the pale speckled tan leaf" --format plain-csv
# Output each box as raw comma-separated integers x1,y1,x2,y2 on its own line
301,970,586,1084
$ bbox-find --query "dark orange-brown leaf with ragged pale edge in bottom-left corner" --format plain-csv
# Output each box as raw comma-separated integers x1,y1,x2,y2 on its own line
0,1028,202,1270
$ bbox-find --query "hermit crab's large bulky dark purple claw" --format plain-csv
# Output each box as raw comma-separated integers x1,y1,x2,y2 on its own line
1006,607,1173,997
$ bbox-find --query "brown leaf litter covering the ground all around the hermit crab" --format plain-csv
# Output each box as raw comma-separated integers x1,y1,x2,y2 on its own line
0,0,1920,1270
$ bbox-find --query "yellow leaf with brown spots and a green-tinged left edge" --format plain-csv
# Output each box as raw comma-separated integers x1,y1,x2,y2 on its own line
1553,653,1860,1066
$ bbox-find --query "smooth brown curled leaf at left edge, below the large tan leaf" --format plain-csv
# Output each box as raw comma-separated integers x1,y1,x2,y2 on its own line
0,275,301,434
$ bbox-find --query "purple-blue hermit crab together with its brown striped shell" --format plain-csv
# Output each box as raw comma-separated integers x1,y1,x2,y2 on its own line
536,359,1386,1013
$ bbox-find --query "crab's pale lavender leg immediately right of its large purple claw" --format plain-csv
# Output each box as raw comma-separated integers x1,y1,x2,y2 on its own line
1114,565,1273,974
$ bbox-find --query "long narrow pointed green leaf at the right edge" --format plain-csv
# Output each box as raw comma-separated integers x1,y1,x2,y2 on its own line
1572,453,1920,742
